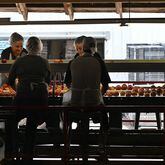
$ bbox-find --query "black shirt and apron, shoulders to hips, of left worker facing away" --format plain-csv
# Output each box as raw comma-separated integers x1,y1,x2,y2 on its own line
8,55,50,109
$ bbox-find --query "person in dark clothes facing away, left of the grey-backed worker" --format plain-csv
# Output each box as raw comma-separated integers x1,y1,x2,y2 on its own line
8,37,50,160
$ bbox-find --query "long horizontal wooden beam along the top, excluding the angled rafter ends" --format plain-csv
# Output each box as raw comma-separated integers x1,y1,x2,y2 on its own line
0,2,165,13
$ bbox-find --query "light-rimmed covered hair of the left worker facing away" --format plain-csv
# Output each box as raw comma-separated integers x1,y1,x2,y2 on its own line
26,36,43,54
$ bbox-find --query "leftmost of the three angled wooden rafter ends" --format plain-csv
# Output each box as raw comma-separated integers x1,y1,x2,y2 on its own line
16,3,28,21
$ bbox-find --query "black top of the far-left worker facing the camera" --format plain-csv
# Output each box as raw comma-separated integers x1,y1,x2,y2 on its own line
1,47,28,60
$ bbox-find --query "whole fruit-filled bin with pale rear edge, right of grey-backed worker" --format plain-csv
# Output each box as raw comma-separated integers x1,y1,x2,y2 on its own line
104,82,165,97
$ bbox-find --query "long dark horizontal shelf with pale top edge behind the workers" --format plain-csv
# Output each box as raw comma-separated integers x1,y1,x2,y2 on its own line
0,60,165,73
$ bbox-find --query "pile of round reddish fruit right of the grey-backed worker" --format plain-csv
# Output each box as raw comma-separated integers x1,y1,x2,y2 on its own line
105,84,165,97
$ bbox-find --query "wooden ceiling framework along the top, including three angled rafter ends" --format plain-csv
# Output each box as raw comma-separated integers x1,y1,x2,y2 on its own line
0,0,165,17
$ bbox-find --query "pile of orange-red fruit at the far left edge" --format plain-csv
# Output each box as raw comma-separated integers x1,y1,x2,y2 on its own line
0,84,16,96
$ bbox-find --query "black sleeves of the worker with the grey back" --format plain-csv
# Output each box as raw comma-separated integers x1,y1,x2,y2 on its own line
64,52,111,92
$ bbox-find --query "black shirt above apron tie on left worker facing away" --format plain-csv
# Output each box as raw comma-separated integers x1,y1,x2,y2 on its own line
8,55,50,92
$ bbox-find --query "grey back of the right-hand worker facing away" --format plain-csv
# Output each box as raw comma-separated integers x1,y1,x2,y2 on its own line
71,54,101,105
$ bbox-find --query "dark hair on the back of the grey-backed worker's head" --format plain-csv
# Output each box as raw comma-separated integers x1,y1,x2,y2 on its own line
83,37,97,52
